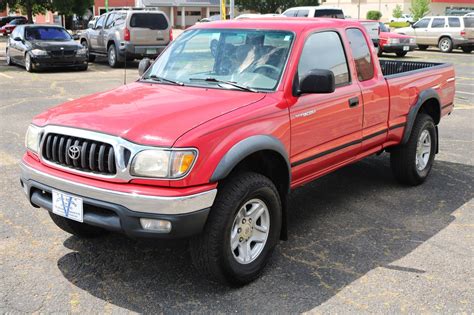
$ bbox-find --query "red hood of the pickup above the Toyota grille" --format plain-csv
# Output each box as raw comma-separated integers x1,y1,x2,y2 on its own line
33,82,265,147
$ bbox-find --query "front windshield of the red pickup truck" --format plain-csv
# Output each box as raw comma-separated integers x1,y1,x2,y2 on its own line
142,29,294,91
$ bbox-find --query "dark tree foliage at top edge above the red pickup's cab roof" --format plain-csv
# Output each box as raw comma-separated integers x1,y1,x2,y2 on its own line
235,0,319,14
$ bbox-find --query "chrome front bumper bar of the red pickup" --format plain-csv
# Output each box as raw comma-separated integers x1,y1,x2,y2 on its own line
21,163,217,215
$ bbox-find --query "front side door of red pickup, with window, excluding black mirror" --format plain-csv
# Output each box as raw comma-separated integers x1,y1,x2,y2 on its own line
290,31,363,183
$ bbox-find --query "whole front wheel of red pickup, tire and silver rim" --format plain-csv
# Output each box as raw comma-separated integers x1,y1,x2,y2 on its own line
190,173,282,285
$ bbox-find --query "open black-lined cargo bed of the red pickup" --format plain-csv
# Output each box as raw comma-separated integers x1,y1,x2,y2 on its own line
379,59,450,79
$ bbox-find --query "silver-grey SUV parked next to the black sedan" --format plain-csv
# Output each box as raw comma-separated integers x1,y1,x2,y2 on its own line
80,9,173,67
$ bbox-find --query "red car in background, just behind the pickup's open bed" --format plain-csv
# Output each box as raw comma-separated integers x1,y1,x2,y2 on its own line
377,22,417,57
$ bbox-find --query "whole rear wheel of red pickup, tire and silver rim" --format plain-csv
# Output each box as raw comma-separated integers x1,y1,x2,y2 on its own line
390,113,437,186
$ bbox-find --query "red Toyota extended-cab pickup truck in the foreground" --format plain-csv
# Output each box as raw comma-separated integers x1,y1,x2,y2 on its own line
21,18,455,284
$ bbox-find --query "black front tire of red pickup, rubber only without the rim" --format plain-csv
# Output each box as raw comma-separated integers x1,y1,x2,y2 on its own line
190,172,282,285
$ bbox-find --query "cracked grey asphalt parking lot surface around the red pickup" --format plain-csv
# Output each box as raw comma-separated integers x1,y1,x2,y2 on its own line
0,35,474,314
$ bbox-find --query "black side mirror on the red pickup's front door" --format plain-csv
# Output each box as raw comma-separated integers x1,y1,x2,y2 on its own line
298,69,336,95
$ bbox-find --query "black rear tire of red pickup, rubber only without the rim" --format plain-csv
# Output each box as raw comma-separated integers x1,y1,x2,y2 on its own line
390,113,438,186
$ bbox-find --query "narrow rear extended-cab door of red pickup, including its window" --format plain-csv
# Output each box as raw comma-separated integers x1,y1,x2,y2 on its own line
346,28,390,152
